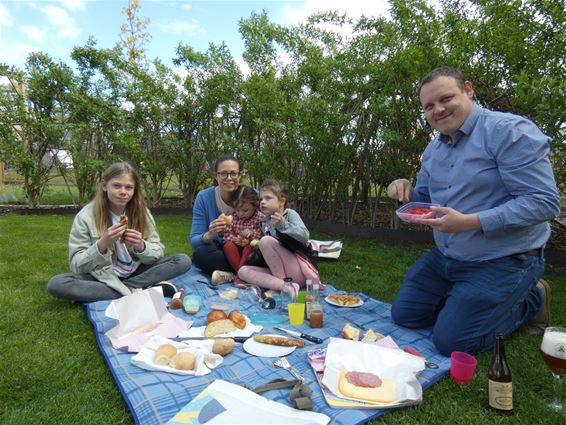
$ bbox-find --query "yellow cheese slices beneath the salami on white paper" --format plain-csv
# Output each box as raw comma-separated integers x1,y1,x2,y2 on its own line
338,370,397,403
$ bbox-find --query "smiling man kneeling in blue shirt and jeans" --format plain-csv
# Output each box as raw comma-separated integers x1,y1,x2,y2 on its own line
387,67,560,355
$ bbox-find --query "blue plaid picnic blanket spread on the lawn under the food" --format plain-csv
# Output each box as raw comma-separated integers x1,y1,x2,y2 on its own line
86,268,450,425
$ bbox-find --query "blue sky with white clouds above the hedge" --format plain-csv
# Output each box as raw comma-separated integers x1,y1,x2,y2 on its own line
0,0,394,72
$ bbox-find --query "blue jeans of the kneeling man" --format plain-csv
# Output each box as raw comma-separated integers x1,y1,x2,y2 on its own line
391,248,544,356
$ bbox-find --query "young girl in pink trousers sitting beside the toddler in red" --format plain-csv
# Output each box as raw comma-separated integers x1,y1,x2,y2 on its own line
238,180,320,292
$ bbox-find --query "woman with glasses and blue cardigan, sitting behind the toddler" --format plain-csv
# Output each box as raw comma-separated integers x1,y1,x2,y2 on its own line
189,154,244,285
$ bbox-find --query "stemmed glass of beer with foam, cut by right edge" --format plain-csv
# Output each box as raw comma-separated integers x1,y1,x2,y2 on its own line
540,326,566,414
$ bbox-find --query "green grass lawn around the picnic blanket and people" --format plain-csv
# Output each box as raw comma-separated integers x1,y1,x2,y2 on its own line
0,214,566,425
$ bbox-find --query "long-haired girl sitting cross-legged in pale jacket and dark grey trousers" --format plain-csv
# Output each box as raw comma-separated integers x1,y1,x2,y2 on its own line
47,162,191,302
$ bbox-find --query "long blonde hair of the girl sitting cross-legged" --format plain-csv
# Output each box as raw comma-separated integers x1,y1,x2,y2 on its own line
94,162,149,237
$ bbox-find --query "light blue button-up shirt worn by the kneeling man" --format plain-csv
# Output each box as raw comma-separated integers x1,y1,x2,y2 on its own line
411,105,560,261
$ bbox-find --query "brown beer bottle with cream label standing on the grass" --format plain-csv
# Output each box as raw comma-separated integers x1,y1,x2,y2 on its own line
487,333,513,415
